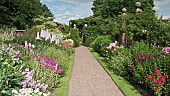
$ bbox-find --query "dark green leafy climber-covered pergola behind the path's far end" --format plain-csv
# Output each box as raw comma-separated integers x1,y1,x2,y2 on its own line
70,16,119,43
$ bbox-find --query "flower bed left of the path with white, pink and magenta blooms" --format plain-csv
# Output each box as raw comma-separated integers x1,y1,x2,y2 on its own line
0,27,74,96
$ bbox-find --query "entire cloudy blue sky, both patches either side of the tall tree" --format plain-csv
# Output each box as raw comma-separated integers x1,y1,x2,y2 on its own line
41,0,170,24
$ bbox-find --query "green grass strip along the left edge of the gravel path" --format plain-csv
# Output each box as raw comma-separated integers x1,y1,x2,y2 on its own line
52,54,74,96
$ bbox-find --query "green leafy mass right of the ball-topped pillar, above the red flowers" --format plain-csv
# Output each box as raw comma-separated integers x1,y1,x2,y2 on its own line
127,12,170,46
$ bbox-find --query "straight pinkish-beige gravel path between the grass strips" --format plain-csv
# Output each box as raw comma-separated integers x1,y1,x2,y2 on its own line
68,46,124,96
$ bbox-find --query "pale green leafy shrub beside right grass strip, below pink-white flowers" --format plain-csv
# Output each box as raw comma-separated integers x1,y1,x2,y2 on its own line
108,48,133,79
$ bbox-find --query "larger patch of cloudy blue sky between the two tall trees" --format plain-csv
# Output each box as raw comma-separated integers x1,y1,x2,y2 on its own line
42,0,93,24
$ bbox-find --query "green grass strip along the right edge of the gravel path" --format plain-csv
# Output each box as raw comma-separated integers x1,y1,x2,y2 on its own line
89,48,142,96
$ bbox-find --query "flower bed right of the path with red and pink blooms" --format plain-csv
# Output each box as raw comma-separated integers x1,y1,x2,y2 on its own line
93,42,170,96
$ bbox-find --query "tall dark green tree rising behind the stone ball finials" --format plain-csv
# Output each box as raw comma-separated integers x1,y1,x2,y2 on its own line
92,0,154,18
